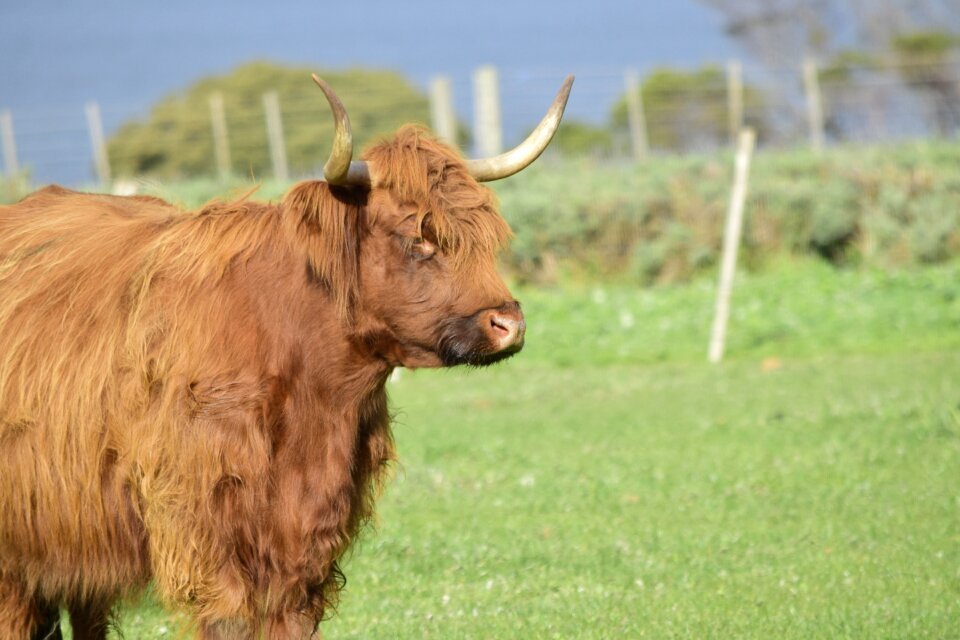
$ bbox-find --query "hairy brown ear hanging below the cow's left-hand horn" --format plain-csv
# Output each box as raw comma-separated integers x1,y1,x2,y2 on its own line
282,180,368,317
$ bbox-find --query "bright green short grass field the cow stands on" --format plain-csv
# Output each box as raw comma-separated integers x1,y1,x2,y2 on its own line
65,261,960,640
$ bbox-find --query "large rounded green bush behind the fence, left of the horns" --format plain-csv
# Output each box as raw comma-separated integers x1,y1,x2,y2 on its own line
108,62,429,178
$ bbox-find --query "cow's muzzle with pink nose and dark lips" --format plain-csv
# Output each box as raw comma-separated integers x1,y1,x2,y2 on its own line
440,301,527,366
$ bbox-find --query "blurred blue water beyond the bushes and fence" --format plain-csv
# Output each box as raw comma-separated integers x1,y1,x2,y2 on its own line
0,0,736,184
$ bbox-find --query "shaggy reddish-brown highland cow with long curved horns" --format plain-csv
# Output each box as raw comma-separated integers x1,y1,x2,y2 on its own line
0,78,572,640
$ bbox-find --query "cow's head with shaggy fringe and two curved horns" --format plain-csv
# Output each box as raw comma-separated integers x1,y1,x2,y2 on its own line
285,76,573,367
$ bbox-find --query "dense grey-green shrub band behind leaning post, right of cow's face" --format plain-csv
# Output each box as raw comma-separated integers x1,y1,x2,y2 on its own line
494,143,960,282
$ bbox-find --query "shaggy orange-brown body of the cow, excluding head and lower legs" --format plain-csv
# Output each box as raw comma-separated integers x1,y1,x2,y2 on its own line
0,182,392,635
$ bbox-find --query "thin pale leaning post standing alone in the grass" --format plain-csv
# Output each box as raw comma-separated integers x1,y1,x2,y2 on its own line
707,129,756,364
